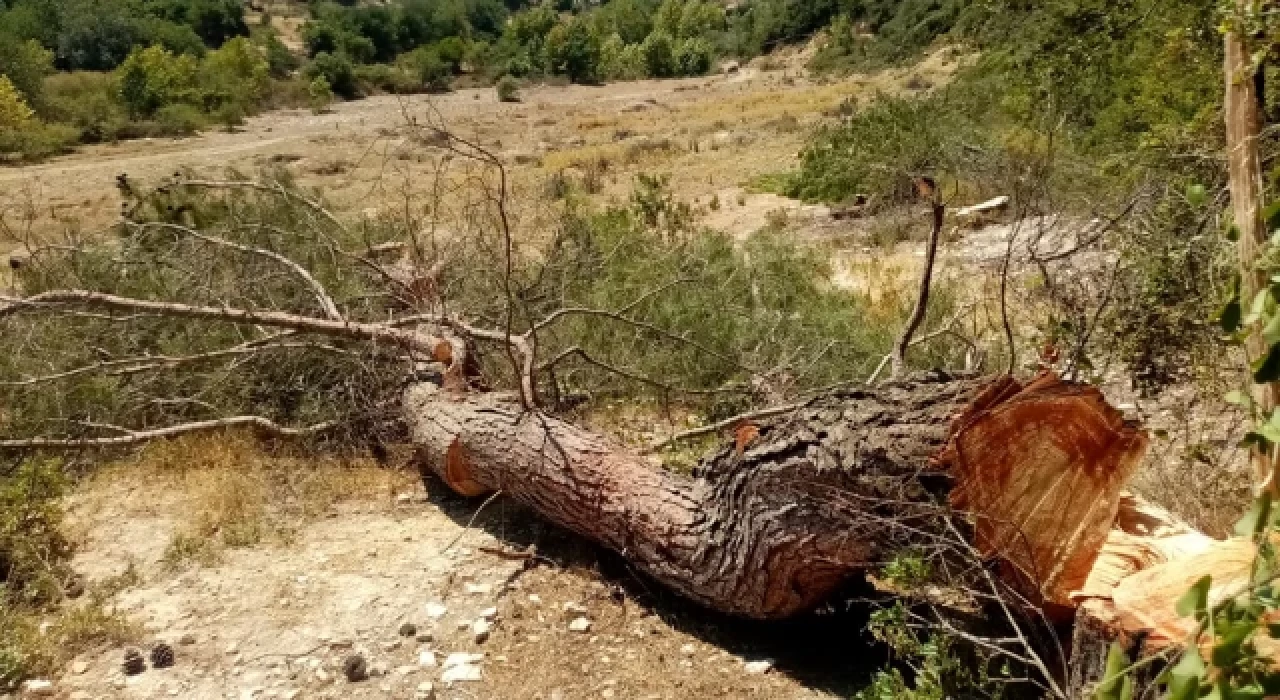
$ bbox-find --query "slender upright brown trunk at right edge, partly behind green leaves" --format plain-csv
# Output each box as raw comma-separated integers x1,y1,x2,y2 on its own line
1225,9,1280,491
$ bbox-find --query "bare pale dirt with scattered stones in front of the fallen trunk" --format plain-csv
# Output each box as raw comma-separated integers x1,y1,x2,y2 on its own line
47,440,882,700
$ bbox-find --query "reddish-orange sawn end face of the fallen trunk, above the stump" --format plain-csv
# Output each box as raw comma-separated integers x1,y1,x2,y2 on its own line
937,374,1147,608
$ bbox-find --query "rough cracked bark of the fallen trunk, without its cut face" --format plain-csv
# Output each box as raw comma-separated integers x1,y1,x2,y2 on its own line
404,372,987,618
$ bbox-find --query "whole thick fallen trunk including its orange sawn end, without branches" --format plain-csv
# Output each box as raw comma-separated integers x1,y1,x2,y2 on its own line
404,374,1146,618
